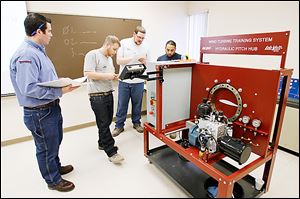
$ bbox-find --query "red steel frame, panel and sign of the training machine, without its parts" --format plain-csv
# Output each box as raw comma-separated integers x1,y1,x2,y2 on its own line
144,31,292,197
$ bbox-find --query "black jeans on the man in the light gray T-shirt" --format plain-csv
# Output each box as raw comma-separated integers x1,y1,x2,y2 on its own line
90,94,118,157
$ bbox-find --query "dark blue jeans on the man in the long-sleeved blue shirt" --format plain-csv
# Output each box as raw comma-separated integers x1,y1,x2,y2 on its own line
24,105,63,185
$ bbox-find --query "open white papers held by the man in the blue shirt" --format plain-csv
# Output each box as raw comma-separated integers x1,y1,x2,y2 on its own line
37,77,87,88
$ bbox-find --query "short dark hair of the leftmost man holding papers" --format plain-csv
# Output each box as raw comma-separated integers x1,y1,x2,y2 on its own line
24,13,51,36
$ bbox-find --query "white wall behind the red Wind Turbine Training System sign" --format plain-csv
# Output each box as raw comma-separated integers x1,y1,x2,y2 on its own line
188,1,299,78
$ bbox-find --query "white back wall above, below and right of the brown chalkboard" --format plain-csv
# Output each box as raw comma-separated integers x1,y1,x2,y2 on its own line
1,1,188,141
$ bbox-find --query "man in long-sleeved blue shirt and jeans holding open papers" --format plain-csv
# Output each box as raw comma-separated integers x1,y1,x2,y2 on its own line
10,13,78,192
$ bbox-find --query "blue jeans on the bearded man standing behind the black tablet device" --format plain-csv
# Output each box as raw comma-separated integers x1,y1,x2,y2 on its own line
116,81,144,128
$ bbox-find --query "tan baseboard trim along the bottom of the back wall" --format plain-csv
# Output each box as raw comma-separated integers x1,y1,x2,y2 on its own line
1,111,147,147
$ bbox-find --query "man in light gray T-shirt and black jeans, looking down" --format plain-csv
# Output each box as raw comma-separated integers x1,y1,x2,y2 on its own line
84,35,124,164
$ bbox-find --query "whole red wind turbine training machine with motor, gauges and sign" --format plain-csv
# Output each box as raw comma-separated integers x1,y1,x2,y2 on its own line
144,31,292,197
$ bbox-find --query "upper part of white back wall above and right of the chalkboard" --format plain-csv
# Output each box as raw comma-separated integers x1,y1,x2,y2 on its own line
26,1,188,60
